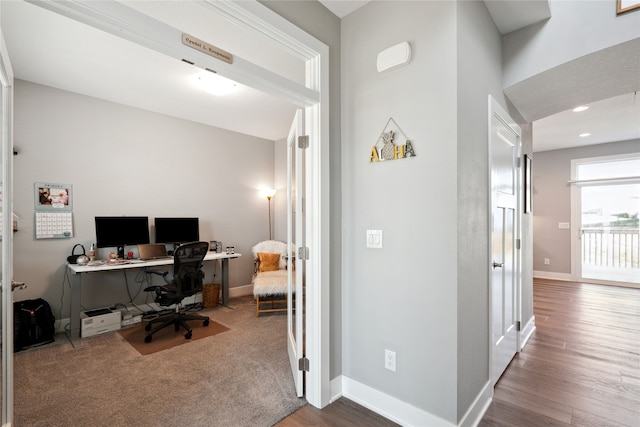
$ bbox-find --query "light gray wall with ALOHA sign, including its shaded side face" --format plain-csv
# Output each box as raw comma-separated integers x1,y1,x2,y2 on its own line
342,2,532,423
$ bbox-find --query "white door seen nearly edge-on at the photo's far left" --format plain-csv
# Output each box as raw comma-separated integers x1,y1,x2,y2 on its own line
0,28,13,426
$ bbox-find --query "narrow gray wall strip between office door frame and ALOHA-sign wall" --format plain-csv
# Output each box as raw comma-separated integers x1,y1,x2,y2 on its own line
260,0,342,379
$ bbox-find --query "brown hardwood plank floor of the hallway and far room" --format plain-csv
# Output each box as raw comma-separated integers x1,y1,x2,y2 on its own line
276,279,640,427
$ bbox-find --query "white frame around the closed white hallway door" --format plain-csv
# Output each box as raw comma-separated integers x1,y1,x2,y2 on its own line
487,95,524,388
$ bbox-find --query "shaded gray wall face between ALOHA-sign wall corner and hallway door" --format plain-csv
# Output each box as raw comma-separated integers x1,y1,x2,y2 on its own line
457,2,505,420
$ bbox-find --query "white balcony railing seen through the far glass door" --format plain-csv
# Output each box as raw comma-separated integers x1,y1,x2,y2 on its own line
580,228,640,269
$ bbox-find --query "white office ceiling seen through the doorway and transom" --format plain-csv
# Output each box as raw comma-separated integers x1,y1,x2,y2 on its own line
0,1,304,140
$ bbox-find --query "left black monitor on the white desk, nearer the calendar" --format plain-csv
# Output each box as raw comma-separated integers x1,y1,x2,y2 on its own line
96,216,150,258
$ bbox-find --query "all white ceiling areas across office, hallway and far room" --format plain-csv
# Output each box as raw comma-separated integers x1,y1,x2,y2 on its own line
0,0,640,151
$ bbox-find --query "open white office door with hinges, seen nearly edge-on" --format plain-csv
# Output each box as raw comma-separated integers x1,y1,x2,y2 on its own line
287,109,306,397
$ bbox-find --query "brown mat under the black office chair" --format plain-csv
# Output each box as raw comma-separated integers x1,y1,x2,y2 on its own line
118,320,229,354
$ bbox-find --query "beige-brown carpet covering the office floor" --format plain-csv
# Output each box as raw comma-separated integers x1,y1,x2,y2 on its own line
14,297,306,427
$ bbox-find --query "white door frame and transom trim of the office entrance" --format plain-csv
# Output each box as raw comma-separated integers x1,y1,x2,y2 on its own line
13,0,330,408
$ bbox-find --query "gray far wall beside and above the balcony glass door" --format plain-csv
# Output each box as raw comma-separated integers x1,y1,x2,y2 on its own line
532,139,640,278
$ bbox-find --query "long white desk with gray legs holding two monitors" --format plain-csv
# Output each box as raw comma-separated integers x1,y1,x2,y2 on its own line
67,252,242,347
